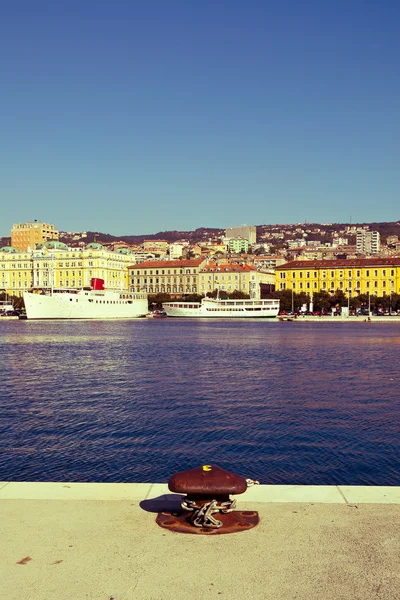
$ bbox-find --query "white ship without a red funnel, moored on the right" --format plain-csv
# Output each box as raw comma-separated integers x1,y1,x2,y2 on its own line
163,298,279,319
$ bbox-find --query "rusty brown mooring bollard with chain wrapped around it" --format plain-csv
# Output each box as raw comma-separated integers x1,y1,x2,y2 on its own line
157,465,259,535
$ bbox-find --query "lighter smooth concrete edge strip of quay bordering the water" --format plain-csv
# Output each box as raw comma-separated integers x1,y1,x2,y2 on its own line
0,481,400,504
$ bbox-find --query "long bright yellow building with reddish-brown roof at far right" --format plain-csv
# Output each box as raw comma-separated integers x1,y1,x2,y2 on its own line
275,256,400,297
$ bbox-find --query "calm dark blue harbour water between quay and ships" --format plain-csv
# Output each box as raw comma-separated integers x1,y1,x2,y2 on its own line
0,319,400,485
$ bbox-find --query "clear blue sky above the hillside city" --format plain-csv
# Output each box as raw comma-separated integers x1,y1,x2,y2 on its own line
0,0,400,236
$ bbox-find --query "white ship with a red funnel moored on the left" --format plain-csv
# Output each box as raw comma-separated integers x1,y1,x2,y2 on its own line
24,278,148,319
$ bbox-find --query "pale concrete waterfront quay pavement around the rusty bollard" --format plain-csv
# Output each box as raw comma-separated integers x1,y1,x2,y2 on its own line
0,482,400,600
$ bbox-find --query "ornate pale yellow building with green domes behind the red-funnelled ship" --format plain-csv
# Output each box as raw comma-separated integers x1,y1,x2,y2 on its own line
0,241,133,296
